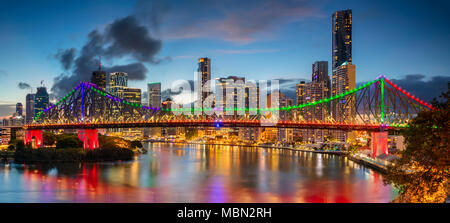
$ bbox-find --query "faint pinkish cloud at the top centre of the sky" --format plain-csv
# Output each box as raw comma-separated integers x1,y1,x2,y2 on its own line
153,0,322,44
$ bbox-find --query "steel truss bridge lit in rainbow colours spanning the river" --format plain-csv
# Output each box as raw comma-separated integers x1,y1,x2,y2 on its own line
24,76,434,155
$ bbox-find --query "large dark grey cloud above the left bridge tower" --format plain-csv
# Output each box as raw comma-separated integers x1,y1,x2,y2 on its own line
51,15,166,96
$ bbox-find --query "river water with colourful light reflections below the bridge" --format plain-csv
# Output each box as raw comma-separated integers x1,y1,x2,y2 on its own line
0,143,396,202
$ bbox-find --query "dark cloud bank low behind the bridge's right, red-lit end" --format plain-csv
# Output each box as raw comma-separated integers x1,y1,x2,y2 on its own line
391,74,450,102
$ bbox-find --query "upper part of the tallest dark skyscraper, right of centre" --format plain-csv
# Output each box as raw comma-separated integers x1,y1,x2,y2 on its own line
332,10,352,70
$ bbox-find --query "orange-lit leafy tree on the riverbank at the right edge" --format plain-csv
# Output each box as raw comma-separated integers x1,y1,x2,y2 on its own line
385,90,450,203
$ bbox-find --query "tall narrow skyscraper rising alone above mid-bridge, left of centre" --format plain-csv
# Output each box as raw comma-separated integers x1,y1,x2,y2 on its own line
197,57,211,105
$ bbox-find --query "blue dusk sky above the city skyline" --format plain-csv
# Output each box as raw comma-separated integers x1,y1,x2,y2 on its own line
0,0,450,116
